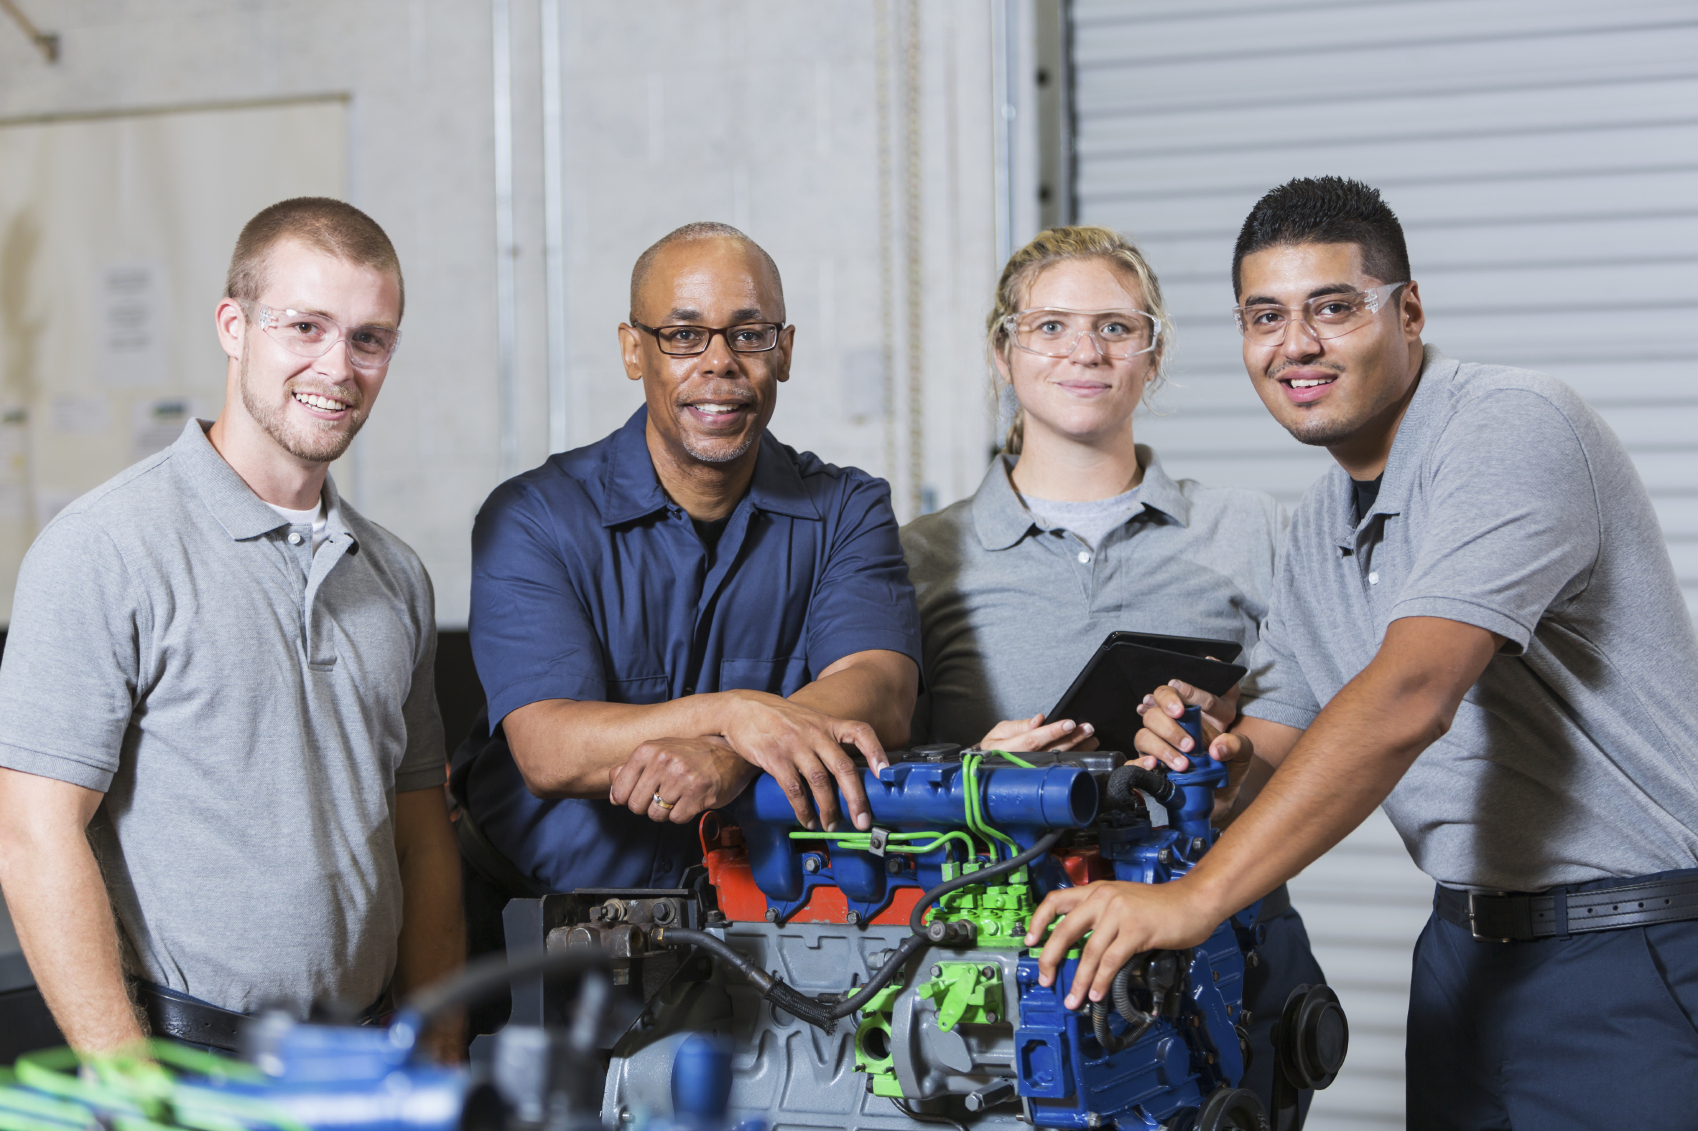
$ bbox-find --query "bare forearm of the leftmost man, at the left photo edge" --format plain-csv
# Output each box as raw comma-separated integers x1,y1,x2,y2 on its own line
0,769,144,1051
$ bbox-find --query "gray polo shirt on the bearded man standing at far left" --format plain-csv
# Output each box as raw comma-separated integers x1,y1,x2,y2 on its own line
0,421,445,1012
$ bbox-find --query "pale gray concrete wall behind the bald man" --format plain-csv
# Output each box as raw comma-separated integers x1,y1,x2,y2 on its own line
0,0,997,627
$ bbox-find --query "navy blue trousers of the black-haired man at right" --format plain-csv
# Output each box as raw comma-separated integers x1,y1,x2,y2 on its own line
1405,896,1698,1131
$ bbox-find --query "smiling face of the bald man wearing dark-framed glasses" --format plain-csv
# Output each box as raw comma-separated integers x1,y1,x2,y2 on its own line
620,238,795,465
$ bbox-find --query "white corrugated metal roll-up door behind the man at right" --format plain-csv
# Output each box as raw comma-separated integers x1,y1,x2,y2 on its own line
1070,0,1698,1129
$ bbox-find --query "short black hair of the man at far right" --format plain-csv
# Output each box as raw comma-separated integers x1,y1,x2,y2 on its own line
1233,177,1409,295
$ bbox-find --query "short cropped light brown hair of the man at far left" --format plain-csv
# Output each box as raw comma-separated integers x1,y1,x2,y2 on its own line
224,197,408,316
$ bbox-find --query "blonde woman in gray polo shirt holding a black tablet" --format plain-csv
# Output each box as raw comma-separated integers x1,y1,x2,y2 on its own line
902,228,1324,1111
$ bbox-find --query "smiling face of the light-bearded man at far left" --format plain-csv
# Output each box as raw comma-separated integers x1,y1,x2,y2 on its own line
221,239,401,464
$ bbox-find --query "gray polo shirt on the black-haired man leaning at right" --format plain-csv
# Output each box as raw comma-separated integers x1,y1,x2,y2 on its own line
1245,346,1698,892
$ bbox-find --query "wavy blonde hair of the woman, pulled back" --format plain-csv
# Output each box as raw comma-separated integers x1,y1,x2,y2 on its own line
985,224,1173,455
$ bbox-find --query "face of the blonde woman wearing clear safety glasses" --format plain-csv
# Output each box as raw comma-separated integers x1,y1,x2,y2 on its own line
995,260,1160,443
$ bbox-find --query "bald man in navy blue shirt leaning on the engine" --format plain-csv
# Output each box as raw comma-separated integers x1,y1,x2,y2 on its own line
453,224,920,951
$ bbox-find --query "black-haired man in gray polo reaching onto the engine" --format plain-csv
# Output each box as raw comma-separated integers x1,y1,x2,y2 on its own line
1031,178,1698,1131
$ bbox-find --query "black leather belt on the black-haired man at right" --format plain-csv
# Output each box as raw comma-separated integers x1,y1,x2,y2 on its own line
1433,875,1698,943
